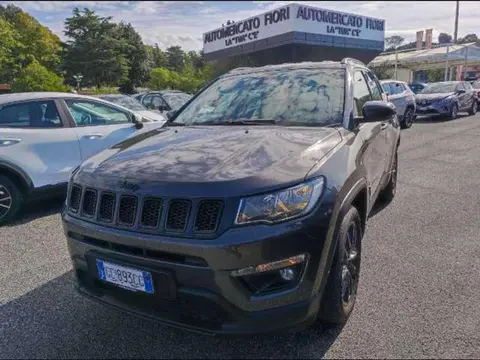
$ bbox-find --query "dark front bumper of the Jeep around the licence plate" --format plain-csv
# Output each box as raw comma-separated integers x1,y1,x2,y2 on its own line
62,191,334,334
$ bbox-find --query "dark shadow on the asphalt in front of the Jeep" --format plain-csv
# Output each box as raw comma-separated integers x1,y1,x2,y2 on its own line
0,271,342,359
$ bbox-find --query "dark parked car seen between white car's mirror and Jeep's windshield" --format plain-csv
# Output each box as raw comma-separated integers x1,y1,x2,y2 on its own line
135,90,192,114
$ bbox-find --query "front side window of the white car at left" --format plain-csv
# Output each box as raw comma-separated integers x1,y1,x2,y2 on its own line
65,100,131,126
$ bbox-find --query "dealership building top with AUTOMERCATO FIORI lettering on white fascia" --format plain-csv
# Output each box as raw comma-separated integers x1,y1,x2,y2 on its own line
203,4,385,65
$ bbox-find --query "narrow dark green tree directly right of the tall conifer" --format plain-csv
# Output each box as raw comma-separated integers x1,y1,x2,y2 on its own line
118,23,149,94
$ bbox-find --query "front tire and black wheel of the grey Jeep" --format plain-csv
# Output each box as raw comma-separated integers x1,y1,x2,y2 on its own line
317,206,363,325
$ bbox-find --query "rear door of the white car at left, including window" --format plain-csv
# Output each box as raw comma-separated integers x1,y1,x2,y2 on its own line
0,99,82,188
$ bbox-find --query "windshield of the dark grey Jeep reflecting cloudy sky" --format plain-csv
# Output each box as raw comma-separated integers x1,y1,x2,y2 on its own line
175,68,345,126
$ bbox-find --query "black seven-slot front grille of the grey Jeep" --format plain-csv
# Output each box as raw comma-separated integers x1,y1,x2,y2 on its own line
68,183,225,237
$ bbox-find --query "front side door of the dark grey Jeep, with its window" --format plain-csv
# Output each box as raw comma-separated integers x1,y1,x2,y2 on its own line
353,69,385,195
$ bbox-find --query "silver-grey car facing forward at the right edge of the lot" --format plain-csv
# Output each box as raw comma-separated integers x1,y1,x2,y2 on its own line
415,81,478,119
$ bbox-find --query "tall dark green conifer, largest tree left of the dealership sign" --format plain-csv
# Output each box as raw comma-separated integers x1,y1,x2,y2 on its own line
65,8,129,87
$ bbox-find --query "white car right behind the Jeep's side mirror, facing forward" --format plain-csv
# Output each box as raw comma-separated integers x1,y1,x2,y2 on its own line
380,80,416,129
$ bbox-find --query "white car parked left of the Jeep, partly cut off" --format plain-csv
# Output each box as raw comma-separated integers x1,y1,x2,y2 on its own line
0,92,164,225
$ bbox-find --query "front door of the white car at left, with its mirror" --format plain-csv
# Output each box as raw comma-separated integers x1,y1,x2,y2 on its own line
64,99,158,161
